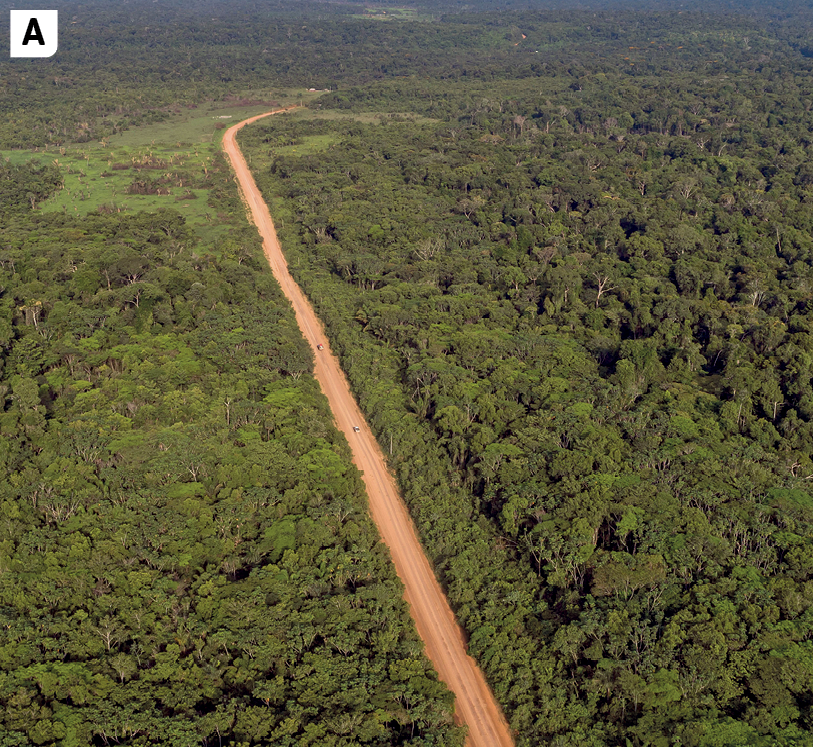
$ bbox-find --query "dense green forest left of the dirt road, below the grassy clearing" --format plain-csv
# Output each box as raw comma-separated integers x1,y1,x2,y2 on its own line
0,142,461,747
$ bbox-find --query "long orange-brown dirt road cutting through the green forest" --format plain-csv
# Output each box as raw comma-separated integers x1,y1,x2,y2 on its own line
223,110,513,747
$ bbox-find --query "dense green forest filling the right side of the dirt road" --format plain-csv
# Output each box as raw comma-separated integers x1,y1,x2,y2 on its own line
236,14,813,745
